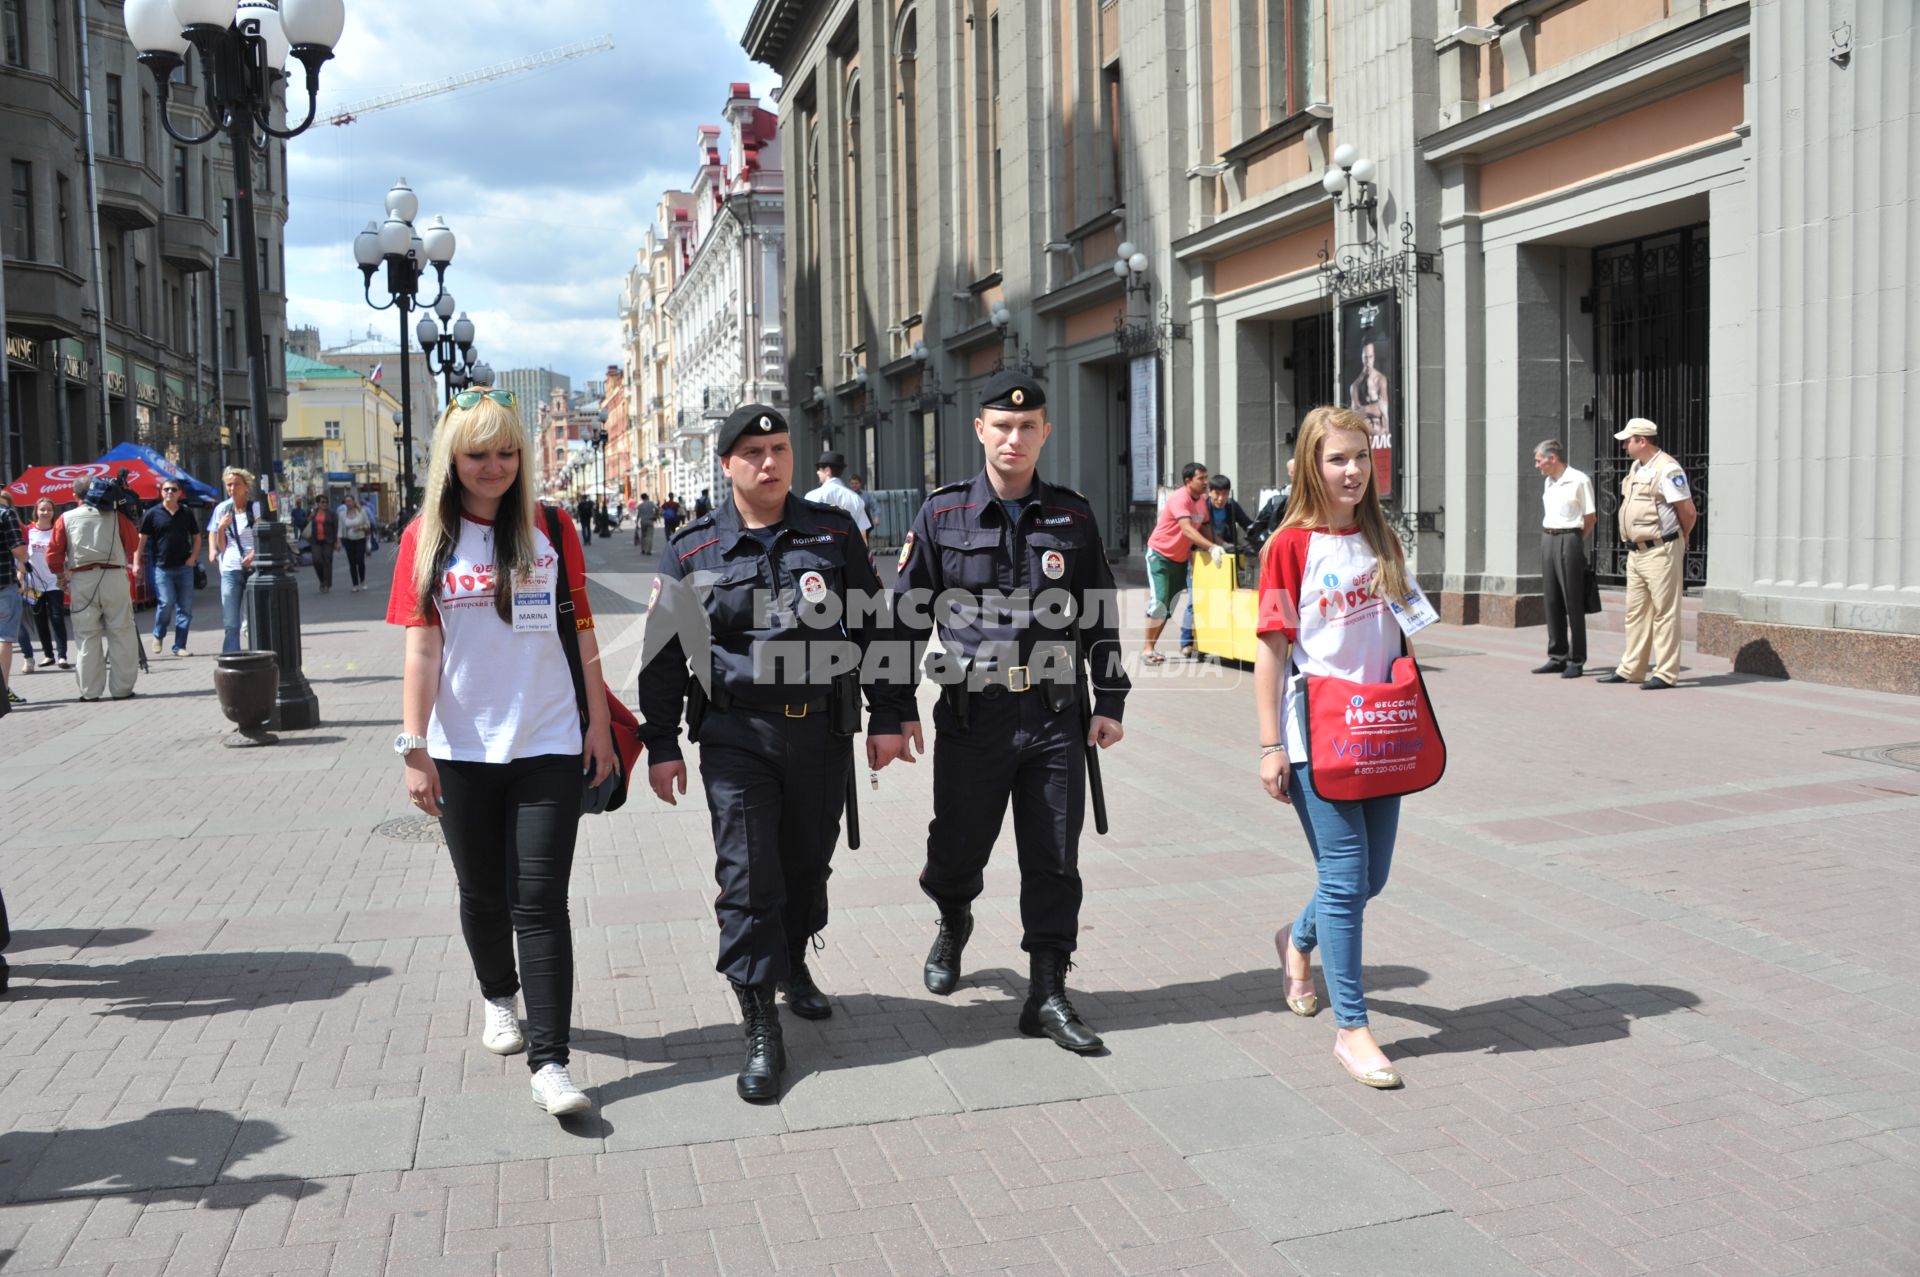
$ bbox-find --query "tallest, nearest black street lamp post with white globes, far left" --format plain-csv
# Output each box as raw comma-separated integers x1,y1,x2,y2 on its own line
123,0,348,730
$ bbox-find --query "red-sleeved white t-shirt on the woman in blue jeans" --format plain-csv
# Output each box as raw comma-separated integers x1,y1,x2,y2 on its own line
1258,528,1402,764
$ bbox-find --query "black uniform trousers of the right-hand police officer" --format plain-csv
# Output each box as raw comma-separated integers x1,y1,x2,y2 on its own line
920,687,1087,952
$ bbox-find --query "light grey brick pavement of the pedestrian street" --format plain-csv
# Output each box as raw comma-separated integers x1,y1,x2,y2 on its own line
0,538,1920,1277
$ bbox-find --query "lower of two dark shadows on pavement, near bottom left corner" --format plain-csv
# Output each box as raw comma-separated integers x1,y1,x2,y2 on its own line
0,1108,309,1210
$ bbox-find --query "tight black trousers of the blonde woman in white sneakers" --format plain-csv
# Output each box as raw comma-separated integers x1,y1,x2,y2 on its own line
437,752,584,1070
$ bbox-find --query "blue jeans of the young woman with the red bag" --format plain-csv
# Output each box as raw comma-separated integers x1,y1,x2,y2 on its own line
1292,762,1400,1029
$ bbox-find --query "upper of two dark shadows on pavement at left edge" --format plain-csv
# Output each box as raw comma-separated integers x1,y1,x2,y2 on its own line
10,952,392,1020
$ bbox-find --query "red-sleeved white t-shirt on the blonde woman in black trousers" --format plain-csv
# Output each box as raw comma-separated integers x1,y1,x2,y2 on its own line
386,515,593,762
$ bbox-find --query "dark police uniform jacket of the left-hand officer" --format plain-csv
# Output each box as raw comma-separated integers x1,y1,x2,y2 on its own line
639,494,920,762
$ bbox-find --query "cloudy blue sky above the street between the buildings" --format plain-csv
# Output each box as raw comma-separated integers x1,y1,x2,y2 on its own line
286,0,776,386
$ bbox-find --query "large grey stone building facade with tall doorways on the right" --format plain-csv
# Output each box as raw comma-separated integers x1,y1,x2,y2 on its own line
743,0,1920,691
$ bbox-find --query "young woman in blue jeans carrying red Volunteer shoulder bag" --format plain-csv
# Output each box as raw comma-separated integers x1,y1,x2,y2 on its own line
1254,407,1444,1089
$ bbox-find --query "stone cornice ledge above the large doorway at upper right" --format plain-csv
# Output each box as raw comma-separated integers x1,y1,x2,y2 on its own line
1421,4,1749,163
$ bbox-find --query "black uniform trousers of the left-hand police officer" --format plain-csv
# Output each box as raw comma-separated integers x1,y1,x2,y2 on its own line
701,707,852,985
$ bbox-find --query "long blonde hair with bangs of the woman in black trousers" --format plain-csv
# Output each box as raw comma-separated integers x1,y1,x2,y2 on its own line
413,399,537,624
